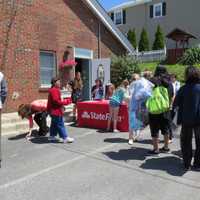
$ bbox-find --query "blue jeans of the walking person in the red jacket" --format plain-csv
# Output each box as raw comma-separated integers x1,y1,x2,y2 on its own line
50,115,67,139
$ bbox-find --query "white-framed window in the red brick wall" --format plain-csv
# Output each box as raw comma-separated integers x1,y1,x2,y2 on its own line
40,51,56,87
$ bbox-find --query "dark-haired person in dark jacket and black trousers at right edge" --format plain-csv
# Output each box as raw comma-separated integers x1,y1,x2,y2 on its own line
173,66,200,170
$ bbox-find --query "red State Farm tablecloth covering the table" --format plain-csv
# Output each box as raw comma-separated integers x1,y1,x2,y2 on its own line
77,100,129,132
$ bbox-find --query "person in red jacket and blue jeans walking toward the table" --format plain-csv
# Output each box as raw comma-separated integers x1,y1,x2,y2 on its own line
47,77,74,143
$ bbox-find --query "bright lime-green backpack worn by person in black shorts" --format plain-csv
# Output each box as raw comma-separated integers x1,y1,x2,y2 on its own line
146,86,170,114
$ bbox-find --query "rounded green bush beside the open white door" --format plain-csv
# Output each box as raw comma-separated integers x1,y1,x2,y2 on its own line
111,56,140,86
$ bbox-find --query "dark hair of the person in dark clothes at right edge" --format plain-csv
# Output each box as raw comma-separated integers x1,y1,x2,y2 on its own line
185,66,200,84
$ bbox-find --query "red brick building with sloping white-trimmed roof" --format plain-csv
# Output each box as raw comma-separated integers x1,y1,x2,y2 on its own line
0,0,133,112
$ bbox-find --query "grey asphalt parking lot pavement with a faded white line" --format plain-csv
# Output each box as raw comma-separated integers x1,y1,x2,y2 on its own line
0,126,200,200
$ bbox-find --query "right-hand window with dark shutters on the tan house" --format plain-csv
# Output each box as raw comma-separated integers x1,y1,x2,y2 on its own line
150,2,166,18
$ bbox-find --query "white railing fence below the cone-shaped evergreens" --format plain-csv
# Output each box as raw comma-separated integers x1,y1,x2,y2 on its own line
133,48,167,62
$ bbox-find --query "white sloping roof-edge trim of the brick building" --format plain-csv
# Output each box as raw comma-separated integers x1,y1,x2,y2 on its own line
82,0,134,54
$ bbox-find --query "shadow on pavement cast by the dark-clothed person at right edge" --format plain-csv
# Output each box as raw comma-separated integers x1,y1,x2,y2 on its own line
140,156,185,176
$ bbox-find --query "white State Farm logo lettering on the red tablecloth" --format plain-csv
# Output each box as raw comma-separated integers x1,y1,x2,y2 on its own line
81,111,122,122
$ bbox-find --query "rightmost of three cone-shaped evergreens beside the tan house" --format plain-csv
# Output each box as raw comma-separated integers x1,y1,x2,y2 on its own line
152,25,165,50
